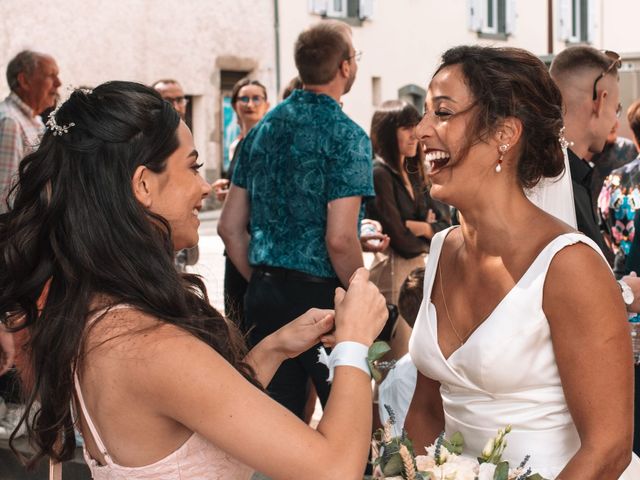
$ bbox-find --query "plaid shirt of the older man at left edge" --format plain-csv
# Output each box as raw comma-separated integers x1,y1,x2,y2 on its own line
0,92,44,212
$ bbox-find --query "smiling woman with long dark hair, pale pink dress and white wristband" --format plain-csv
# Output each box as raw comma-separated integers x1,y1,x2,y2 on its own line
0,82,386,479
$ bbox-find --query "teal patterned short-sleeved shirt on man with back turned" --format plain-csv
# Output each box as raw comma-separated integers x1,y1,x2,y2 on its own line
232,90,375,278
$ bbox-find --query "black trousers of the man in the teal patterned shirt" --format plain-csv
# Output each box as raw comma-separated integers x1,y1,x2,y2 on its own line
245,268,340,418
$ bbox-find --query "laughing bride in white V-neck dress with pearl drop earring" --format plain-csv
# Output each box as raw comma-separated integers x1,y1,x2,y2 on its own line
405,47,640,480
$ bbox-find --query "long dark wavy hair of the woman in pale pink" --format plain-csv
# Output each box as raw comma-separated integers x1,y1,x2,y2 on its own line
0,82,257,466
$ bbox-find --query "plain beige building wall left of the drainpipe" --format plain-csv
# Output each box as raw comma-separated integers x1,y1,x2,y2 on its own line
0,0,275,186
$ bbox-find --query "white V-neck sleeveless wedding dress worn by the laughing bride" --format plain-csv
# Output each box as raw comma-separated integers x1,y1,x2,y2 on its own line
409,227,640,480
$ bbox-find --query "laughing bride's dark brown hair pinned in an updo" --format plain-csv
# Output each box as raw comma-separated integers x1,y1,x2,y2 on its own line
434,45,564,188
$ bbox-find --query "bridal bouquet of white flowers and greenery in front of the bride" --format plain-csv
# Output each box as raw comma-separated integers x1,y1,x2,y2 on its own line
371,405,545,480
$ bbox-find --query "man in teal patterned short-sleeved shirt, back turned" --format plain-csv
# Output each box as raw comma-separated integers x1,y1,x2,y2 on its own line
218,20,374,418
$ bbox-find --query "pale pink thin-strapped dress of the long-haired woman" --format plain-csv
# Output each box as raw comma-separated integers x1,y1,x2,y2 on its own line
73,305,253,480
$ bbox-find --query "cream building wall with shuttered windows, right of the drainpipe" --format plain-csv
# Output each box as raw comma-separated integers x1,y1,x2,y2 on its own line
280,0,640,138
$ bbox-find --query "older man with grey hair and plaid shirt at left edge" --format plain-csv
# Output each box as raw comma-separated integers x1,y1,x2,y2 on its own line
0,50,61,212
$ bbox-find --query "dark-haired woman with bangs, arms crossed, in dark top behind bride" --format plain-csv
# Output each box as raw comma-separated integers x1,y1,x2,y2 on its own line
367,100,450,358
